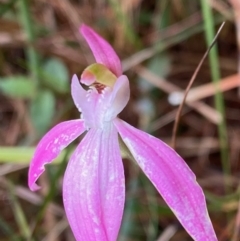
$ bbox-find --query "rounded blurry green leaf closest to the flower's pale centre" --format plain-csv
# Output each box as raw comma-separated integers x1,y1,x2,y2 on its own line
41,58,69,93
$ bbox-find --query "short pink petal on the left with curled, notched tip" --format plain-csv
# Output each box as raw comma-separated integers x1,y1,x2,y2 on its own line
28,120,85,191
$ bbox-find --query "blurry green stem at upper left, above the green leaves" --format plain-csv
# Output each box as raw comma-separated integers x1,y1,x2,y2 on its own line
19,0,40,84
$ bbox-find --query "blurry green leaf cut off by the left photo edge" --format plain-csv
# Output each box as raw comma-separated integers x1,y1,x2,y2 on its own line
0,76,36,99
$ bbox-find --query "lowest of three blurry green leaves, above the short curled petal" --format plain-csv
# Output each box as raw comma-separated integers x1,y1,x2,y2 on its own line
30,90,55,135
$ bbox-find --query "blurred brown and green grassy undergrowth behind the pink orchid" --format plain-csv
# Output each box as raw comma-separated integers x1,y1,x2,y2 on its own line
0,0,240,241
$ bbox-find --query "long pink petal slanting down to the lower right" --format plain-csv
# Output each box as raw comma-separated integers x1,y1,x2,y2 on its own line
114,119,217,241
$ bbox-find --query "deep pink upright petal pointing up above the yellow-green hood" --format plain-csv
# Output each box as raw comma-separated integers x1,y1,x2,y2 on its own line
80,24,122,77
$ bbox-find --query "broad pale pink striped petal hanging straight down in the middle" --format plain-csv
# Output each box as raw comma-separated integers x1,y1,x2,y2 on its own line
63,124,125,241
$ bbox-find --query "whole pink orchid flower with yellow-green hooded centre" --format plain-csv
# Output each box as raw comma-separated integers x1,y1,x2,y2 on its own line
29,25,217,241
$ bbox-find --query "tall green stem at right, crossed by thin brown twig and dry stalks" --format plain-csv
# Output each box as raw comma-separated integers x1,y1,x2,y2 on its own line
201,0,231,191
